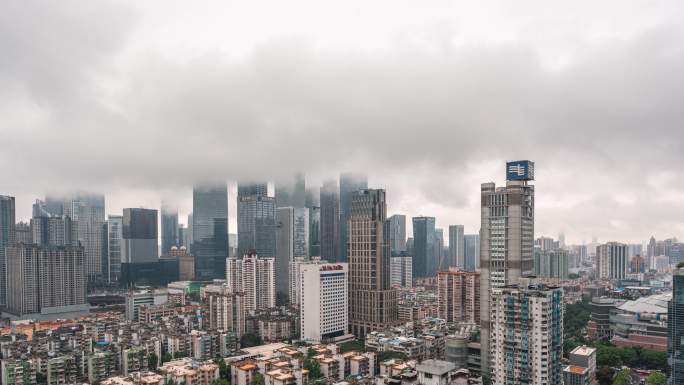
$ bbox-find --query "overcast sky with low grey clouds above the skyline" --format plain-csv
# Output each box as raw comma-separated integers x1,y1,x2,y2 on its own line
0,0,684,242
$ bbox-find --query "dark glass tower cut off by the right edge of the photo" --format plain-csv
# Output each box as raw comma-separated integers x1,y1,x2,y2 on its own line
667,267,684,385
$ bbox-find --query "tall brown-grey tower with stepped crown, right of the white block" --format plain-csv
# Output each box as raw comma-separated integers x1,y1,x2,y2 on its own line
347,189,398,338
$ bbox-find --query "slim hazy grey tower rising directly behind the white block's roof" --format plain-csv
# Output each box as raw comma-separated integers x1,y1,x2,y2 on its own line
321,180,340,261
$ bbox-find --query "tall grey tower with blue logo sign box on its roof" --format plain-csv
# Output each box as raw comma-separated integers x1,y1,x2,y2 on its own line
480,161,534,373
